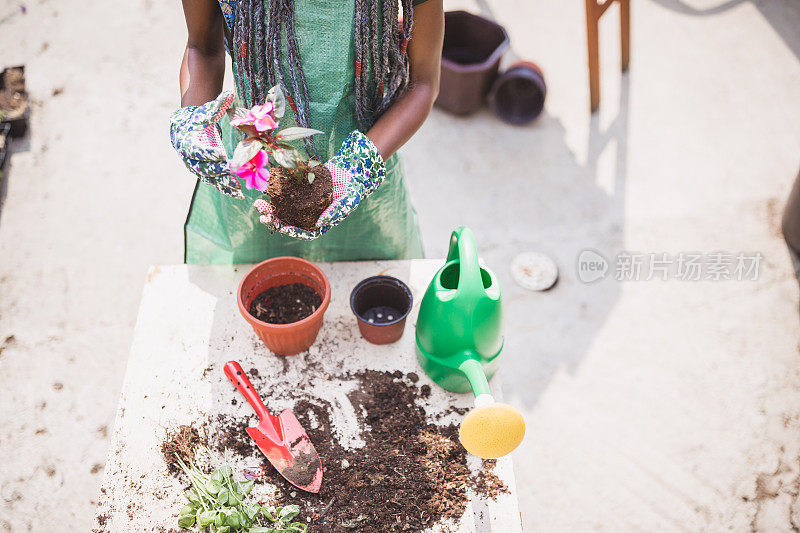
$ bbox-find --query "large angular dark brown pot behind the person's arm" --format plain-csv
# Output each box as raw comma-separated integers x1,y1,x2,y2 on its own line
436,11,509,115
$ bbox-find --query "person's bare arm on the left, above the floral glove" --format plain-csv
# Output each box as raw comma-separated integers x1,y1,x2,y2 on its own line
180,0,225,106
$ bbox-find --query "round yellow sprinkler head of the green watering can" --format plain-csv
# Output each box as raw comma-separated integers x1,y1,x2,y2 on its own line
458,394,525,459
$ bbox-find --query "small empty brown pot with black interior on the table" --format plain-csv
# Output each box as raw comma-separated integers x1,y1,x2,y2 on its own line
350,276,413,344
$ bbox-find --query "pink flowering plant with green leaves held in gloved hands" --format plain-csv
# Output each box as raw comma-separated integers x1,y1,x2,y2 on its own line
228,85,322,192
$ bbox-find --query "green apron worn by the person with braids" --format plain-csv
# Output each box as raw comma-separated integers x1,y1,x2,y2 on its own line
184,0,423,264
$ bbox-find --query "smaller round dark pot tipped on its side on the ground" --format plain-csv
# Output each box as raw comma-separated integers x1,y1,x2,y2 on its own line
489,61,547,125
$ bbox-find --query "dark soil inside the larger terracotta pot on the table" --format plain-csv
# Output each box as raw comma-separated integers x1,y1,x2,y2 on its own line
250,283,322,324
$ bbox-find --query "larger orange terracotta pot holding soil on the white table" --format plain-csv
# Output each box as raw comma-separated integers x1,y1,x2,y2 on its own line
237,257,331,355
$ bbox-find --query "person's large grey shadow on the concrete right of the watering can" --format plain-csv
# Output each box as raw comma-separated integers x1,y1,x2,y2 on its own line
405,75,629,408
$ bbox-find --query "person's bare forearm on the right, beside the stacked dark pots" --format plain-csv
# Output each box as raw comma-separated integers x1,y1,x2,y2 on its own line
367,0,444,159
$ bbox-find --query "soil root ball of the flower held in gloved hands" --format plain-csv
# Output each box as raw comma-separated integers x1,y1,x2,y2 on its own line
267,165,333,230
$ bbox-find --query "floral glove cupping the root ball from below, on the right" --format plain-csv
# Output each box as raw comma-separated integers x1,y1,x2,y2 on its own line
253,130,386,240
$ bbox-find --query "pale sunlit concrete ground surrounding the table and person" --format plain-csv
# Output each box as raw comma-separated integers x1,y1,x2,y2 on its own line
0,0,800,531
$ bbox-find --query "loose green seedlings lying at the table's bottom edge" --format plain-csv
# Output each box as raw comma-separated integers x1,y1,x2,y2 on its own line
178,458,308,533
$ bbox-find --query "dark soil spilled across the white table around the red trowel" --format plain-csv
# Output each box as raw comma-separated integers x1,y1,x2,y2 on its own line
212,371,508,532
